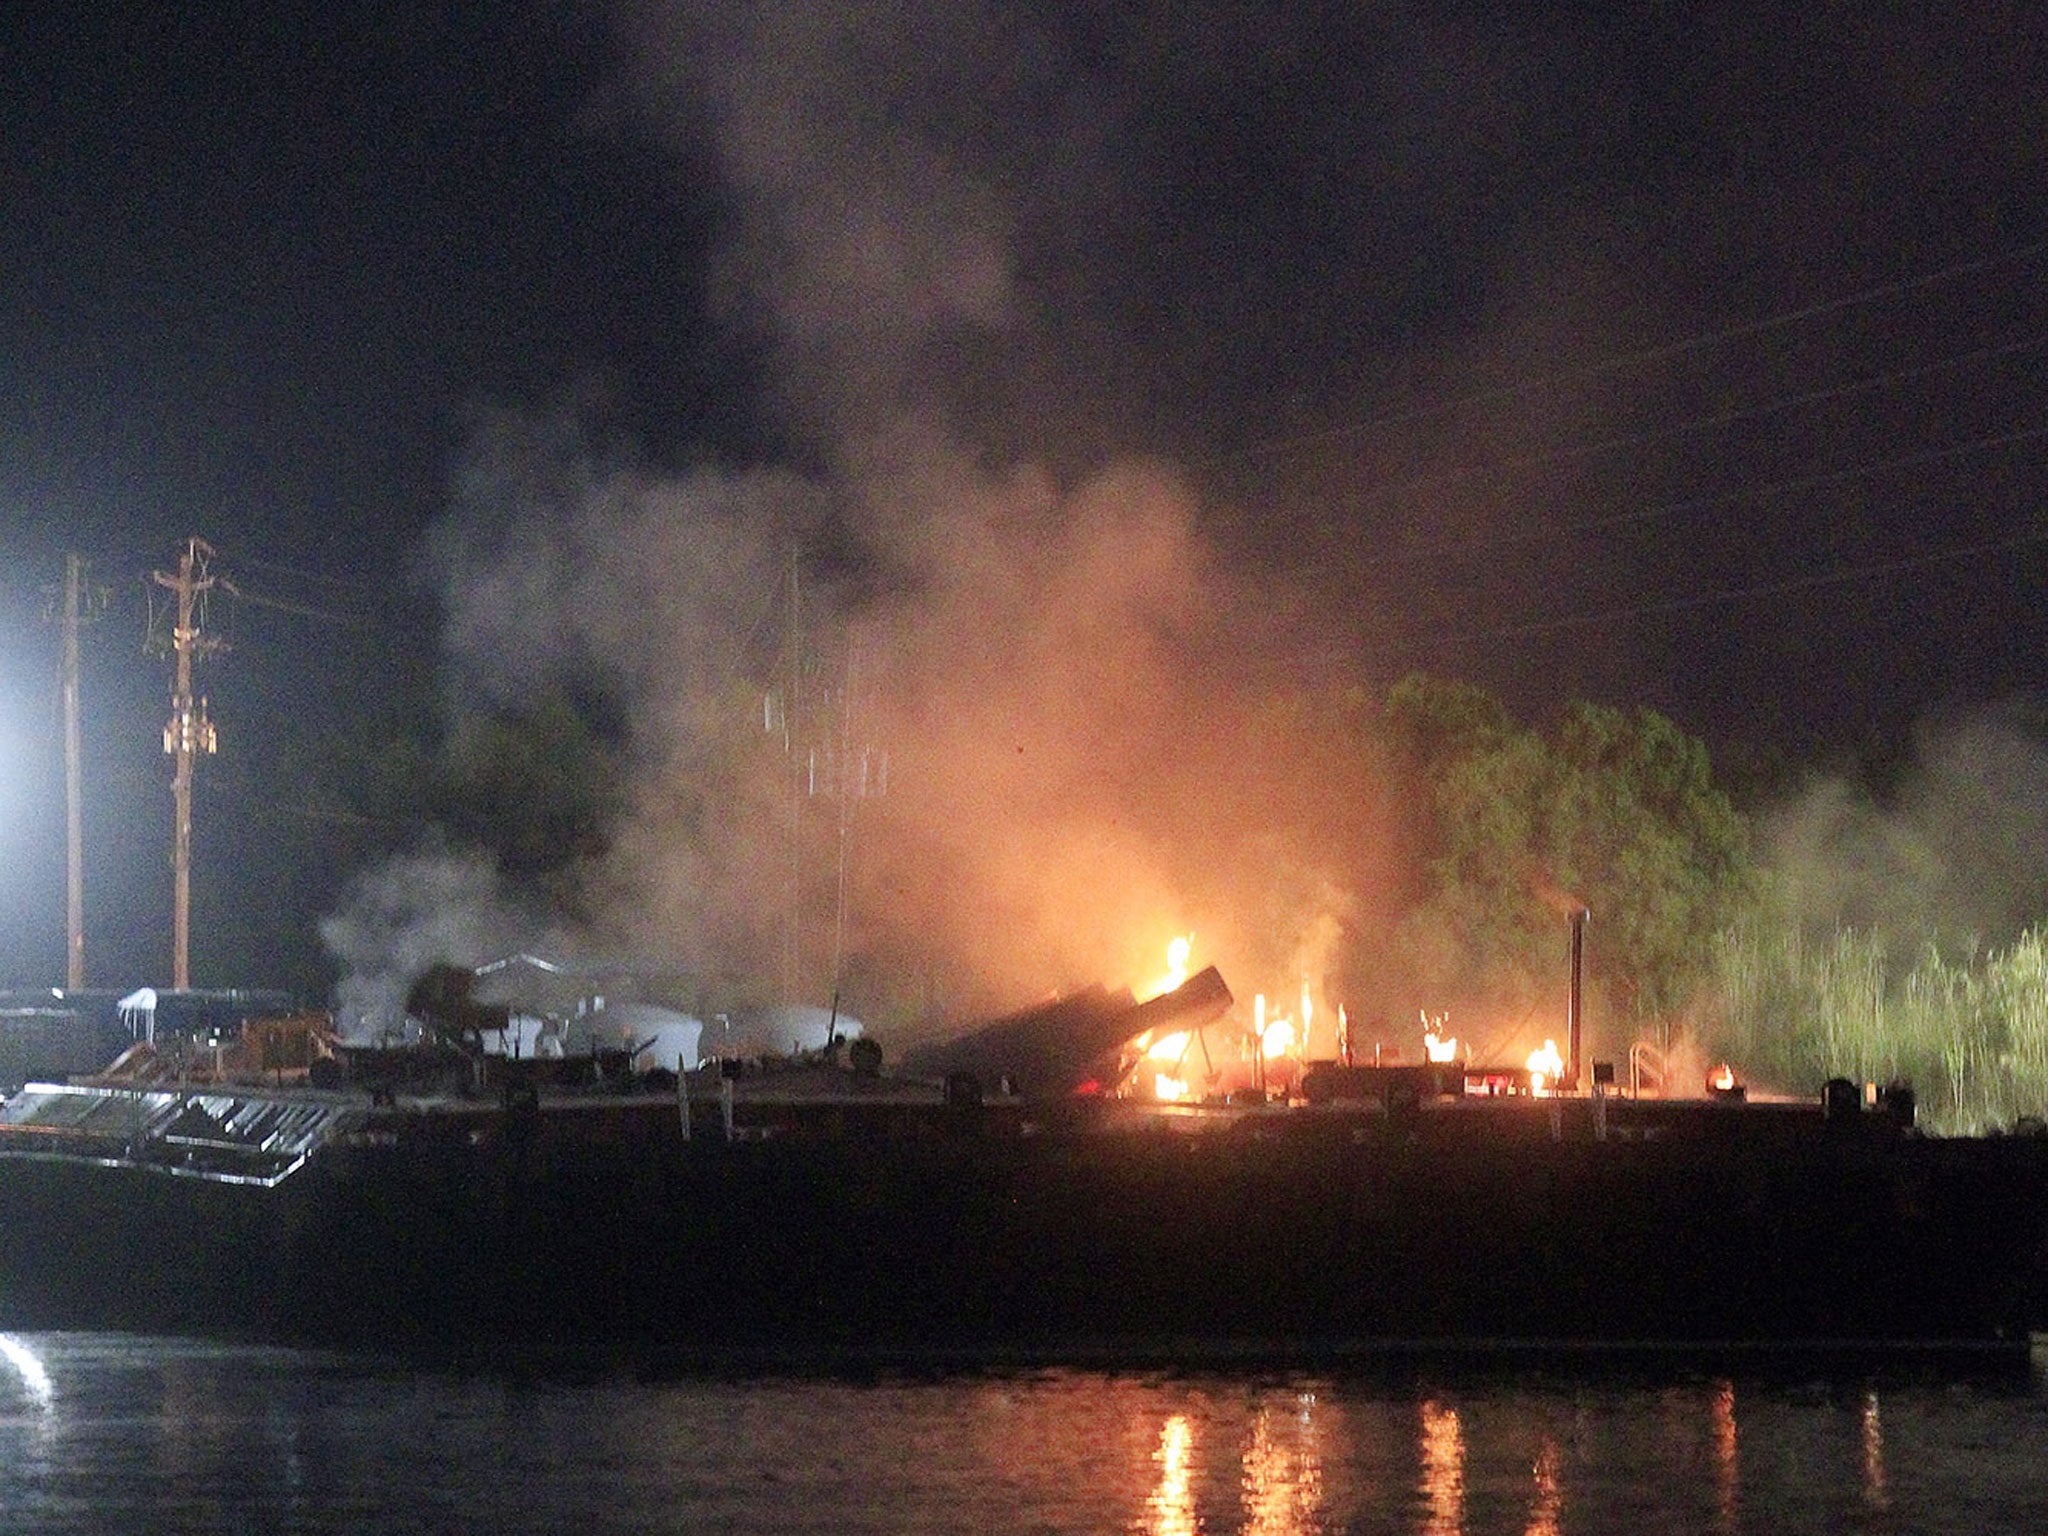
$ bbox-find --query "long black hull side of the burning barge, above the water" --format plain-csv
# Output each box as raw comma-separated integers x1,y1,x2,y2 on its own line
0,1098,2048,1360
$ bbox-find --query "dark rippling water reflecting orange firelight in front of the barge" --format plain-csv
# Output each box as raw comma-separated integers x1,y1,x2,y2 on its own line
0,1333,2048,1536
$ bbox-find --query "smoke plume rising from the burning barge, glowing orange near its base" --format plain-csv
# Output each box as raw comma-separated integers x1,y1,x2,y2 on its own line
330,4,1441,1047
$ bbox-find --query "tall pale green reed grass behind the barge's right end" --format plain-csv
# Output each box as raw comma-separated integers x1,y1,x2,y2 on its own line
1694,924,2048,1135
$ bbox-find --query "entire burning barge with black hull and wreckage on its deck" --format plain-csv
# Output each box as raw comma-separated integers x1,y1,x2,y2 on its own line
0,950,2048,1360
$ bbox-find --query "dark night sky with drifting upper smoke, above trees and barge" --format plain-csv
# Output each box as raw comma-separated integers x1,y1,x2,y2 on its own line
0,0,2048,1003
